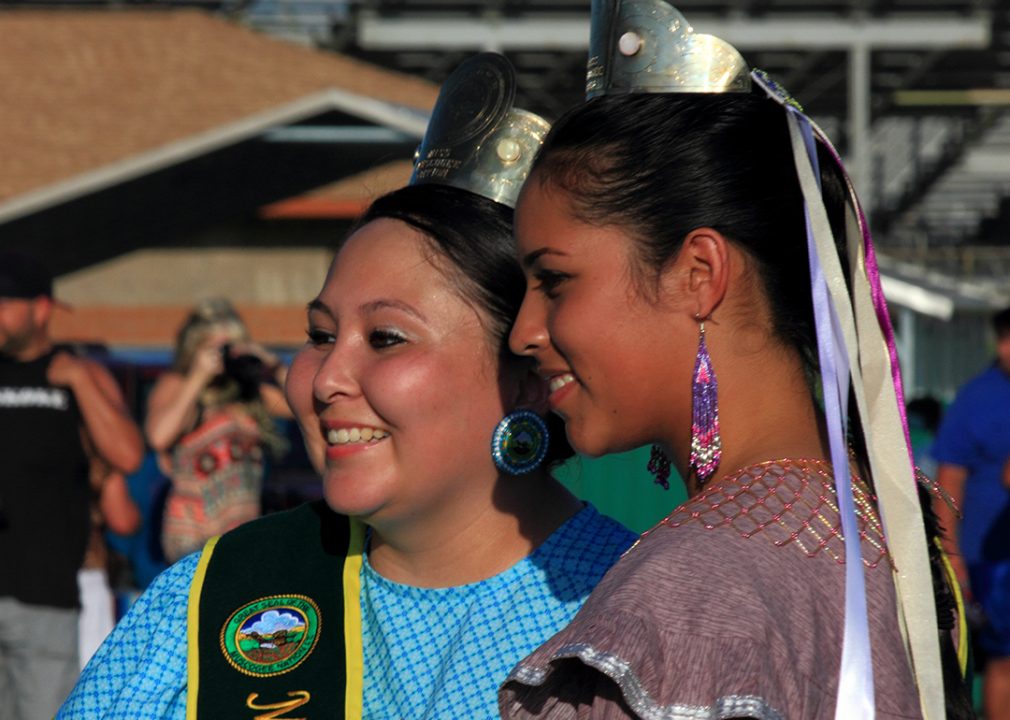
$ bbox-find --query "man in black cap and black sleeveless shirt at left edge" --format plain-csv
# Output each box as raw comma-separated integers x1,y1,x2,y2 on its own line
0,252,143,720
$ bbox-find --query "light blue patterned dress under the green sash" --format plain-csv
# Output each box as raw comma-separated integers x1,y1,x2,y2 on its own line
57,506,636,720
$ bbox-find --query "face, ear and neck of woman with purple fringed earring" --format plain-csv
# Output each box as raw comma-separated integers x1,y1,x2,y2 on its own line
510,174,827,493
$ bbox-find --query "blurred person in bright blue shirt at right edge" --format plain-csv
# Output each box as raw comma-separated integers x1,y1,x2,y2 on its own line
933,308,1010,720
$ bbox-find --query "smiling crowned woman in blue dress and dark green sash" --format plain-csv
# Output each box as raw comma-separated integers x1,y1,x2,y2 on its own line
60,54,635,720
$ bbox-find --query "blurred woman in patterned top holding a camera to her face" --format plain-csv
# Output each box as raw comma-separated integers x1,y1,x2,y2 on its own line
144,298,291,562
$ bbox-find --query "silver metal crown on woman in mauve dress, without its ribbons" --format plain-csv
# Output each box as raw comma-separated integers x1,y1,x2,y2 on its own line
586,0,750,98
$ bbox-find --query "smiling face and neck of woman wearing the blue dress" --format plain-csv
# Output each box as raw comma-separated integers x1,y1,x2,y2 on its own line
286,219,581,587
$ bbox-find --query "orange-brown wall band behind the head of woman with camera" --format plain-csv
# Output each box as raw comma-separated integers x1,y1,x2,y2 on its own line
49,305,306,347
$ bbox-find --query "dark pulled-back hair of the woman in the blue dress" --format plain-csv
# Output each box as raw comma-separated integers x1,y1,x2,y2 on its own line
351,185,575,465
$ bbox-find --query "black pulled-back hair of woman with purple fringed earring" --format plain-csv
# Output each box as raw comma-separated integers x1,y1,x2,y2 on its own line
532,90,975,720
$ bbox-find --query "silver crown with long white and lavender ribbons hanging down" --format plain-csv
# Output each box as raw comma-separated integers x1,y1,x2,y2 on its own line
586,0,944,720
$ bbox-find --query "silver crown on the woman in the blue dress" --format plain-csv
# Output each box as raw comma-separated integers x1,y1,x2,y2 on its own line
410,53,550,207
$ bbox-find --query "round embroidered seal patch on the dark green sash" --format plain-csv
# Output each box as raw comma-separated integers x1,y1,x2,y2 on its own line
221,595,320,678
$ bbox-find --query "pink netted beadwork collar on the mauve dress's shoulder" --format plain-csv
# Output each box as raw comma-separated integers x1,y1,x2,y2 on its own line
628,459,892,568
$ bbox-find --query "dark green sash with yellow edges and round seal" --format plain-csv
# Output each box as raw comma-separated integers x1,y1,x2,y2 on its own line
187,500,365,720
